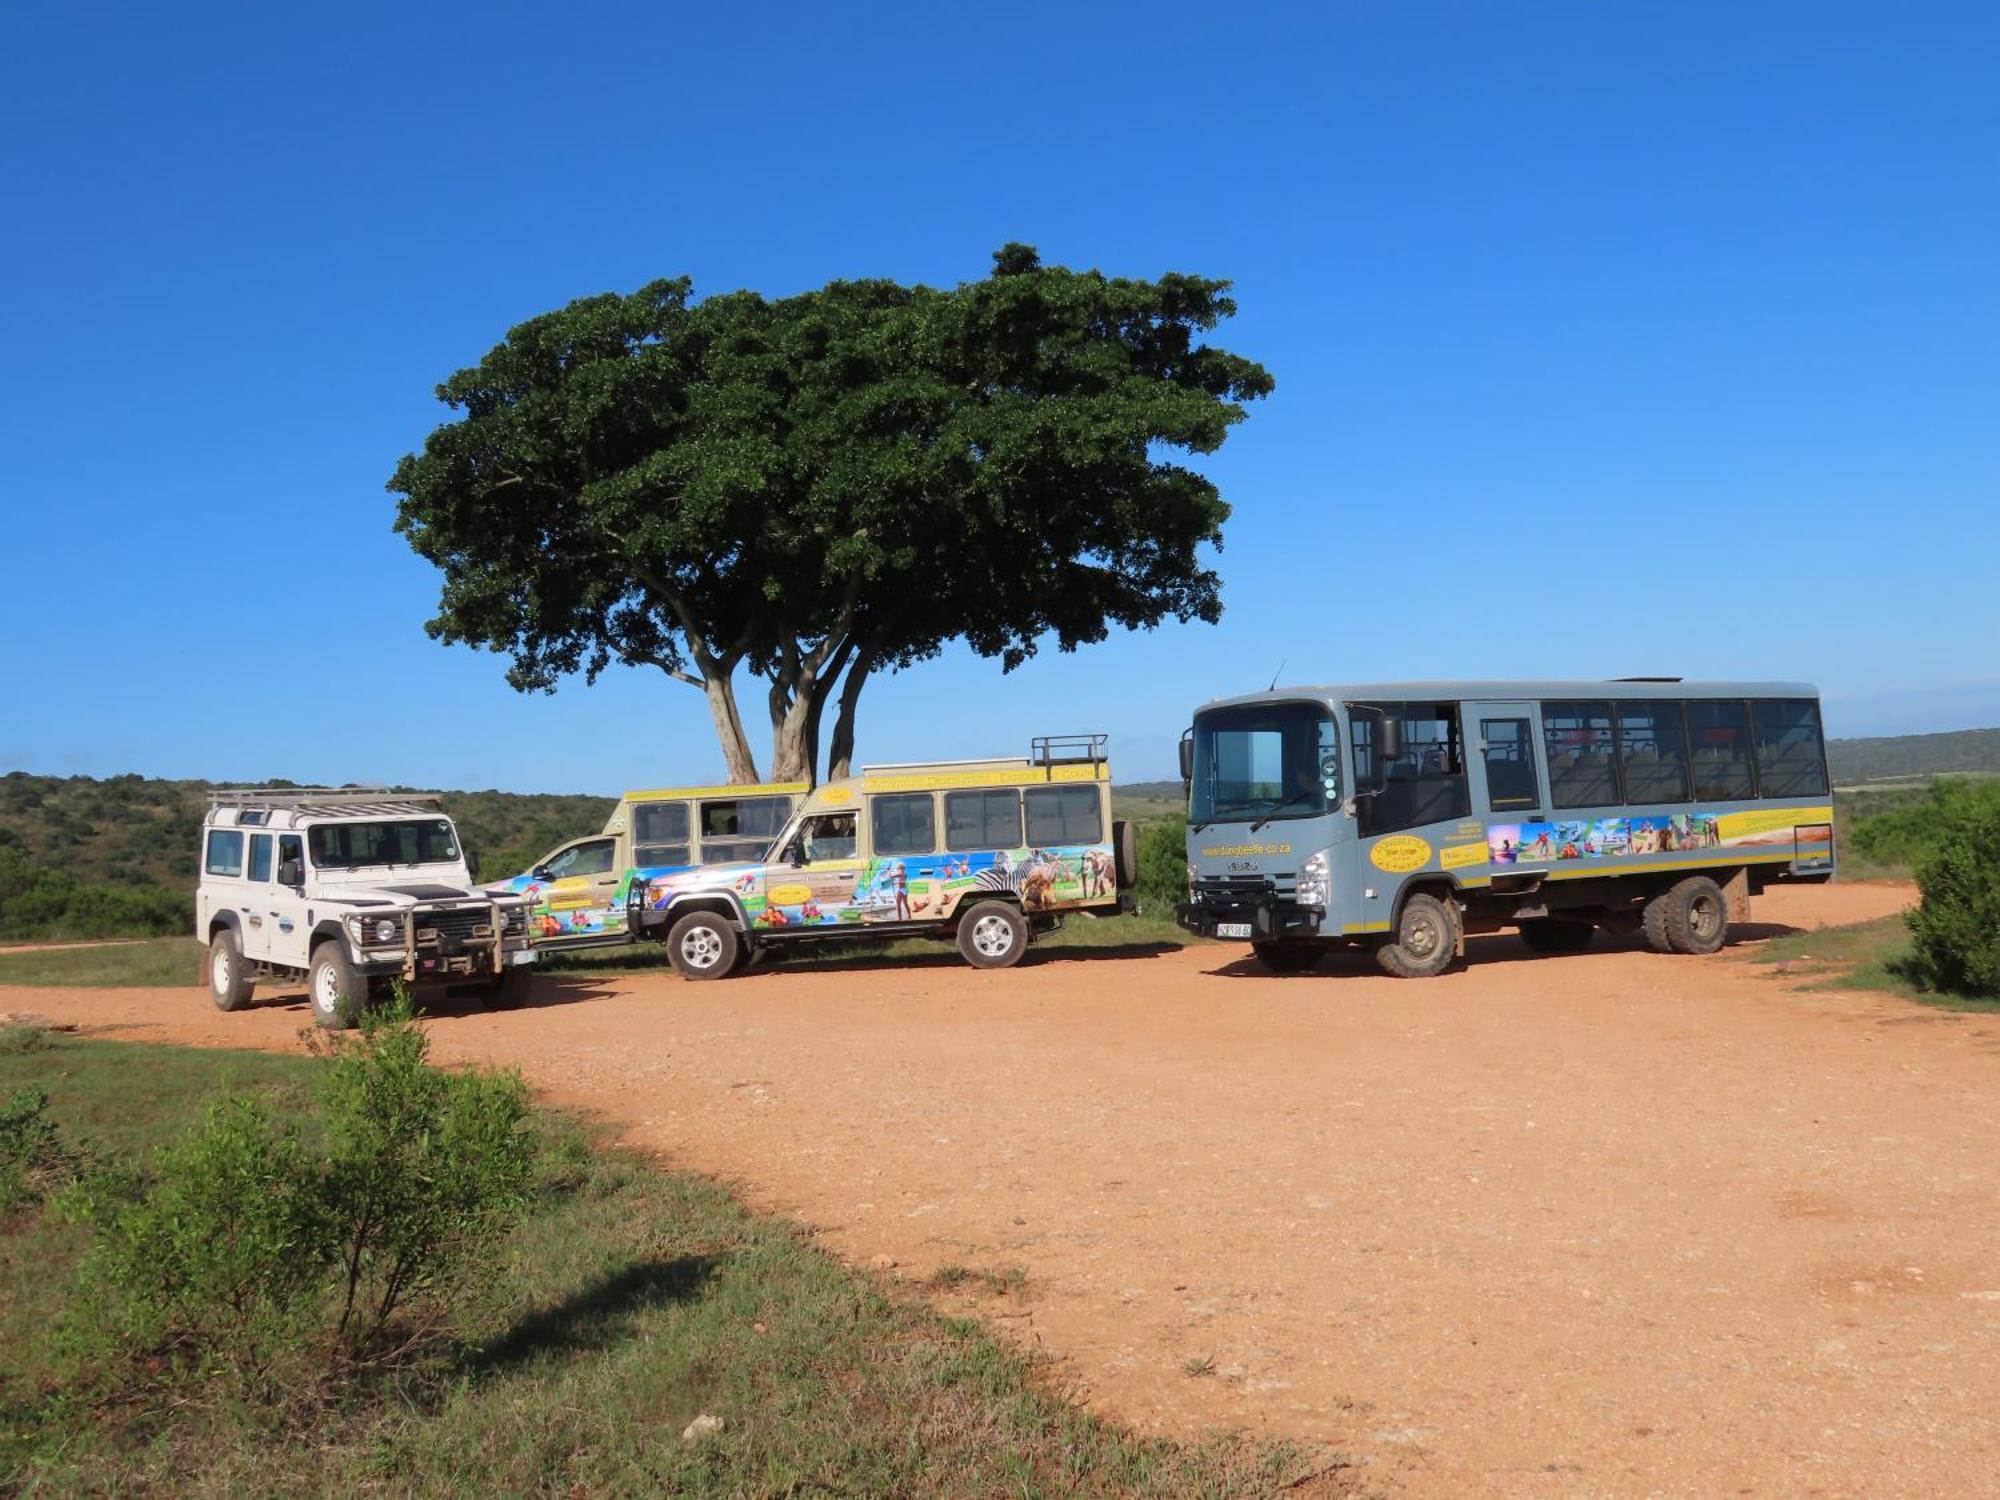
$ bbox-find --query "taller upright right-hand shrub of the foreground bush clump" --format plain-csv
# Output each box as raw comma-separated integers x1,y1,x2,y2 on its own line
318,996,536,1346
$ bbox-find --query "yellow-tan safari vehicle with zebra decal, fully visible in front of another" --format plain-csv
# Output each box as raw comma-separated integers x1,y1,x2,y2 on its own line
626,734,1138,980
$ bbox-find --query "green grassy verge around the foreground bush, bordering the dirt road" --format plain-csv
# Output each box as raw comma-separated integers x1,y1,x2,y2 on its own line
11,1032,1342,1496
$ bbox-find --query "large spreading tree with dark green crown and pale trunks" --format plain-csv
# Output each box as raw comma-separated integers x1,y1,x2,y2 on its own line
388,244,1272,782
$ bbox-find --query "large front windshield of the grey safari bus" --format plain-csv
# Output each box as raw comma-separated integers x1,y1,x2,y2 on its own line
1188,704,1340,824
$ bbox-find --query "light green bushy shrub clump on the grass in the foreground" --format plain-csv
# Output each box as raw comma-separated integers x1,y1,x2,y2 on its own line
62,998,536,1400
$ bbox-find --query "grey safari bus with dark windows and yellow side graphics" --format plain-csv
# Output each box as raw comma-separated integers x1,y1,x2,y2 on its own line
1176,678,1834,978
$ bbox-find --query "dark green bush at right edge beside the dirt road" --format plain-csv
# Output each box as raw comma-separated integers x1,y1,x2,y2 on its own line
1908,782,2000,998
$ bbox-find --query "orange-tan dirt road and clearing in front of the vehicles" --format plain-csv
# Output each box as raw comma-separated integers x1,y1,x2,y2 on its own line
0,886,2000,1496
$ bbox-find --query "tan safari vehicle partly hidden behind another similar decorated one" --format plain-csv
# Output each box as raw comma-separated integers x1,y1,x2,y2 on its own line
490,782,812,948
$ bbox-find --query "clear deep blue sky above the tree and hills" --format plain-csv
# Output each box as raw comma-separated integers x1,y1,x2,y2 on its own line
0,4,2000,792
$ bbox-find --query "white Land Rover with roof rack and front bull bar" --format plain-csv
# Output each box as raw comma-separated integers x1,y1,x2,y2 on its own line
194,786,536,1028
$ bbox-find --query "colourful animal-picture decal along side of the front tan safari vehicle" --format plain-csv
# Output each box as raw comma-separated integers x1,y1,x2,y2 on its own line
634,844,1118,930
